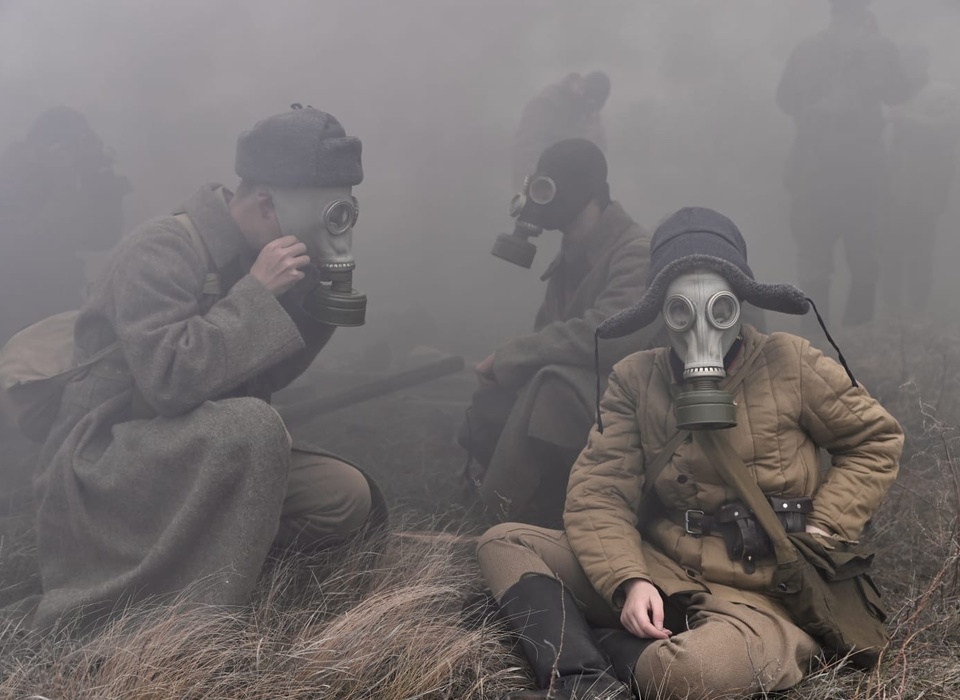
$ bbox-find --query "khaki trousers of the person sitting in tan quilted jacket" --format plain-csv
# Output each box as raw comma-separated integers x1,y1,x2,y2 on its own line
477,523,820,700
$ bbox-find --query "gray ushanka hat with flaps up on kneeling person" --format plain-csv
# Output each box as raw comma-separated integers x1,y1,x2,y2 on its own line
235,105,363,187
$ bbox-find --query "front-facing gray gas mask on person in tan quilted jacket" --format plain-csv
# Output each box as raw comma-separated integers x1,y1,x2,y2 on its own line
662,269,740,430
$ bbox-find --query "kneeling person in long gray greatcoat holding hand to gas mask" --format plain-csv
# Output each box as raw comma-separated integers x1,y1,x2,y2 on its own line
14,105,382,629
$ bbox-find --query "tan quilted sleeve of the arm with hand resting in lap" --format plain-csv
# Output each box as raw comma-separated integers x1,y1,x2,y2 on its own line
563,365,650,606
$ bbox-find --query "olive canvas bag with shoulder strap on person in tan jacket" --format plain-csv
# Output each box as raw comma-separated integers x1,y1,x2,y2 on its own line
699,431,890,670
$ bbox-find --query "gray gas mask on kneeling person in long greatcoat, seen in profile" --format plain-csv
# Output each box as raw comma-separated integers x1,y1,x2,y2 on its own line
270,187,367,326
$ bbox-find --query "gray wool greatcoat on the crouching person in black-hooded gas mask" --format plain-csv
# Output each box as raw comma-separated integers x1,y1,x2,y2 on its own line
481,202,665,518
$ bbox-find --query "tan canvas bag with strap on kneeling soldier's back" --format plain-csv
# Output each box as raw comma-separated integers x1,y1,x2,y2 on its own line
0,213,221,443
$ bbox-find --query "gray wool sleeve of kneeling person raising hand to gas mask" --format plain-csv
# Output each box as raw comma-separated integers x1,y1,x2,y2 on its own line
112,222,305,416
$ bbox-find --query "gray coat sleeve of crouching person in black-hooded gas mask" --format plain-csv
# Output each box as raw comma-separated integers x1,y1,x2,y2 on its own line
493,239,652,388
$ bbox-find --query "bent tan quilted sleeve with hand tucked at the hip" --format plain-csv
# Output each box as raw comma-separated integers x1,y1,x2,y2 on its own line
800,341,903,540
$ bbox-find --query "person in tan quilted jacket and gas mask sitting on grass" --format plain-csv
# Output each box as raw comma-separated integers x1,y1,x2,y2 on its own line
478,208,903,700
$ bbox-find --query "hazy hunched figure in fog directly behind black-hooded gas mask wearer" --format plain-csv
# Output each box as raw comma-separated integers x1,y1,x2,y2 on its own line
513,71,610,190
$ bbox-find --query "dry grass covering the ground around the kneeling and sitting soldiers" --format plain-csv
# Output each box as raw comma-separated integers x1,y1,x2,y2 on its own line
0,326,960,700
